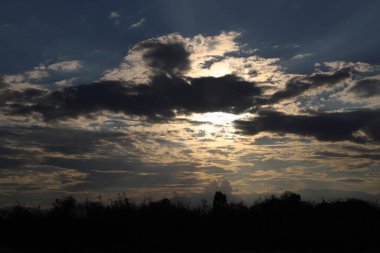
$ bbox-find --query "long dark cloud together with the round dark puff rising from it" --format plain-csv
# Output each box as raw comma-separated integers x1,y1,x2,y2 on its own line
0,40,261,121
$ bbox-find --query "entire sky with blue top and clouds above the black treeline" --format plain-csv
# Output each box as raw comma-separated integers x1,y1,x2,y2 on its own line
0,0,380,206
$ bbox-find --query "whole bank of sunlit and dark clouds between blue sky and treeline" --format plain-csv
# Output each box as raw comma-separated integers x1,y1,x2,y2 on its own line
0,32,380,206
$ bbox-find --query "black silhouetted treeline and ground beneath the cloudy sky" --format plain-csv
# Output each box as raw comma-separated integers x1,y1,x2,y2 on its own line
0,192,380,252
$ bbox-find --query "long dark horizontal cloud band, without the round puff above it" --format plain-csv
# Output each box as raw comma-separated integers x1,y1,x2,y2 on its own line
8,75,261,120
